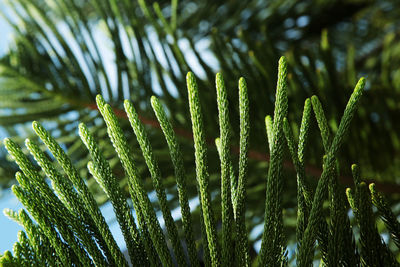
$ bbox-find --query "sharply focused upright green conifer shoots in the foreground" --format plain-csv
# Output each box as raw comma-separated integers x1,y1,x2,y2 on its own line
0,57,399,266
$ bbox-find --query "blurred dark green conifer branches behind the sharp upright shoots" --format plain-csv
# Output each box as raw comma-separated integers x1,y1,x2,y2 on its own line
0,0,400,260
